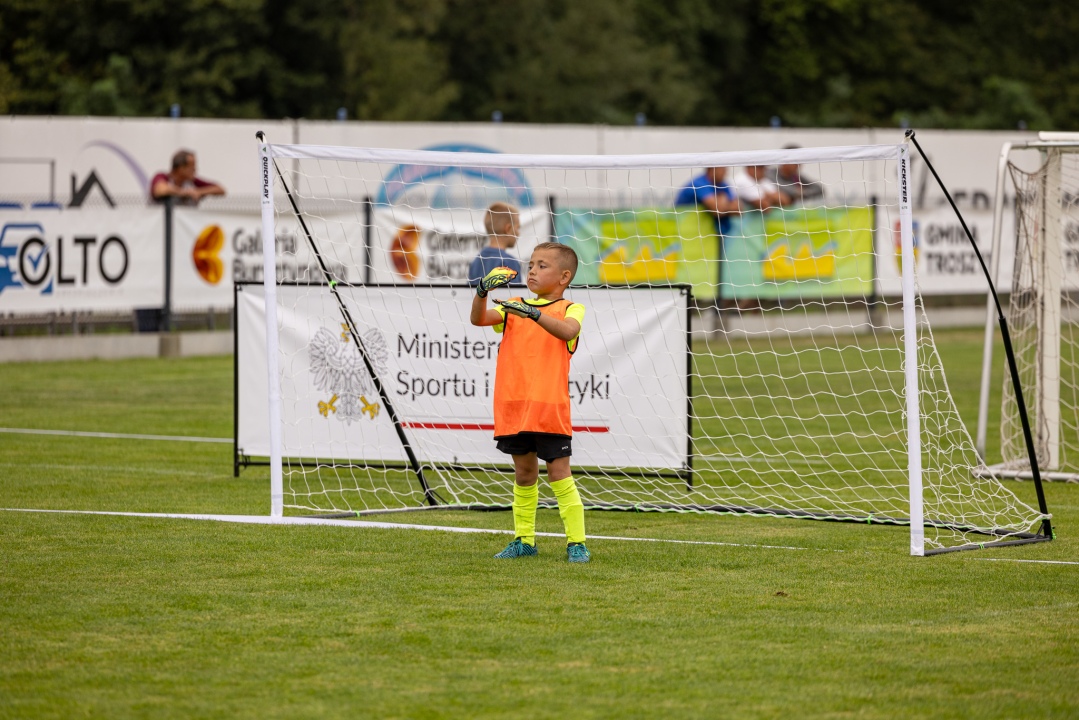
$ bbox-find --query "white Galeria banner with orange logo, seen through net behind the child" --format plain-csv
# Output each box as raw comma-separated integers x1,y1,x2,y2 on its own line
371,206,551,284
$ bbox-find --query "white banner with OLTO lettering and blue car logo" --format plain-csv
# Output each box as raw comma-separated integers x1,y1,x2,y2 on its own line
0,207,165,314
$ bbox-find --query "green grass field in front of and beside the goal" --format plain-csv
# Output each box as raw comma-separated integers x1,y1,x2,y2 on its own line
0,330,1079,718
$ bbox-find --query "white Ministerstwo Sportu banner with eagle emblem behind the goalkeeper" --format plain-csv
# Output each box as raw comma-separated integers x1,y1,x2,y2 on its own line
236,285,689,471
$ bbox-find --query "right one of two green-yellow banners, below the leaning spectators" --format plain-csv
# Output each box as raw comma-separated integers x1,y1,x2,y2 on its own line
721,207,874,299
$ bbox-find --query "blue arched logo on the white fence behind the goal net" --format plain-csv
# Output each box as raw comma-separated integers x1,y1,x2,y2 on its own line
374,144,533,209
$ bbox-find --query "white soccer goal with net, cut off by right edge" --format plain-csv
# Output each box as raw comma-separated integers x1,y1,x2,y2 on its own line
976,133,1079,481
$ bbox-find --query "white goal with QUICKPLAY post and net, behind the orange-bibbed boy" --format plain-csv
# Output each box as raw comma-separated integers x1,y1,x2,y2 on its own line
236,132,1048,555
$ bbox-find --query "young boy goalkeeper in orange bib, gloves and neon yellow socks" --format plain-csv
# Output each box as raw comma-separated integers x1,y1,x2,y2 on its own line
470,243,591,562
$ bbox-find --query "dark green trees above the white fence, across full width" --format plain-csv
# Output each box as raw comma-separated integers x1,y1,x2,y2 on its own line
0,0,1079,130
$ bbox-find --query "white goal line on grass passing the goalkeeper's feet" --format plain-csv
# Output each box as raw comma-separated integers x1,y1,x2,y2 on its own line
0,507,811,553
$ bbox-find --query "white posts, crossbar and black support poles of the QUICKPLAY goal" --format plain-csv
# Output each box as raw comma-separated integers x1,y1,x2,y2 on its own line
248,134,1048,556
